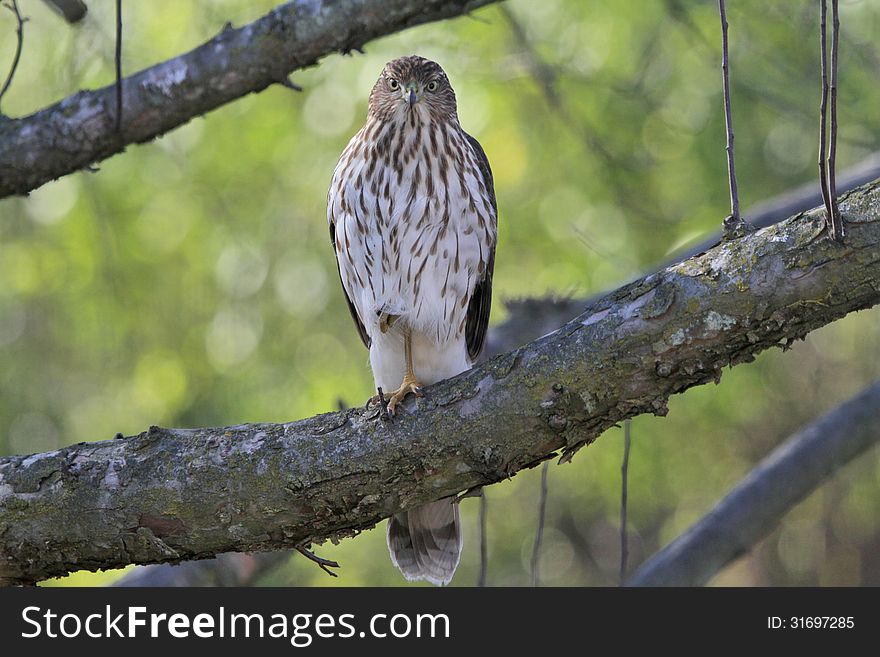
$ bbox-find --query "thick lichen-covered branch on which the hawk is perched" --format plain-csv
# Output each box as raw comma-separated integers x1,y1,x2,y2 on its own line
0,181,880,583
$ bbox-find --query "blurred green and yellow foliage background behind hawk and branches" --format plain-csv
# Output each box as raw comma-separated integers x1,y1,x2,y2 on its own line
0,0,880,585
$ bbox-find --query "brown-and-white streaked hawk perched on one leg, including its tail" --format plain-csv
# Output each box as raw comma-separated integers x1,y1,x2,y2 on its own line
327,56,497,584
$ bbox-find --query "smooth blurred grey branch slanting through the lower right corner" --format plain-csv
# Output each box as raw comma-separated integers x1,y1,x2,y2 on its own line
627,382,880,586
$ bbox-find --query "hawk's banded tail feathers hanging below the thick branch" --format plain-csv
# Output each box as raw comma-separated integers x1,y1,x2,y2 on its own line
388,498,461,586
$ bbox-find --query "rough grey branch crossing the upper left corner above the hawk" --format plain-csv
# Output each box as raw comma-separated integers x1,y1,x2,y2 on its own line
0,0,497,198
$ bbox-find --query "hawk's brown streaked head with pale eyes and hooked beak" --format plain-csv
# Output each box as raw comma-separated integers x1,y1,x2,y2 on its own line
370,55,457,121
